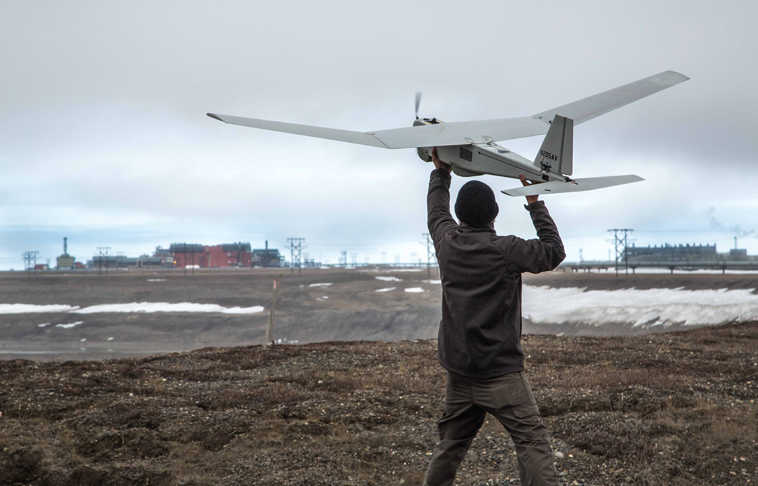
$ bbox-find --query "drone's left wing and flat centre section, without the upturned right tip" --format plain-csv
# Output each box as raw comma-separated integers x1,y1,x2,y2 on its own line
207,113,548,149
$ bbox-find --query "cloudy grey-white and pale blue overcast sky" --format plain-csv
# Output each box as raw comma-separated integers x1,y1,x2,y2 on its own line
0,0,758,269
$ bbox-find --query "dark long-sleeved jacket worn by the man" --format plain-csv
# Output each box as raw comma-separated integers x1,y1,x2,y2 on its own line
427,169,566,378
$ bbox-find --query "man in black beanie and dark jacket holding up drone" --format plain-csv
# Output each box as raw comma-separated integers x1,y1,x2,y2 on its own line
424,149,566,486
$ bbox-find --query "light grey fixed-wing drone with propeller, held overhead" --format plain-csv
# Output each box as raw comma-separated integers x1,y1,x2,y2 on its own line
207,71,690,196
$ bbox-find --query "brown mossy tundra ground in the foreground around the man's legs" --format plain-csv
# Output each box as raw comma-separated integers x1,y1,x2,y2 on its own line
0,323,758,485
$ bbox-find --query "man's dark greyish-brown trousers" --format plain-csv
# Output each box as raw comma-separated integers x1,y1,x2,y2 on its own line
424,372,558,486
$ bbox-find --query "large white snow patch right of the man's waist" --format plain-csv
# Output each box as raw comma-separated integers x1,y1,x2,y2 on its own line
523,285,758,327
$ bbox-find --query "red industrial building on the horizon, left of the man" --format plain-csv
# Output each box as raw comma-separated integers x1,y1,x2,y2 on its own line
169,242,252,268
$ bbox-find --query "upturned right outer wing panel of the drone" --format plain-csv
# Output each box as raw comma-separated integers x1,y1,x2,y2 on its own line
534,71,690,125
